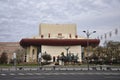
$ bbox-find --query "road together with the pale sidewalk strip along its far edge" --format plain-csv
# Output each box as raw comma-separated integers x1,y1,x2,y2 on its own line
0,66,120,80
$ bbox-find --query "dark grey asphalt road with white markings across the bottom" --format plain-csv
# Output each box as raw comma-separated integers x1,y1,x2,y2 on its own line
0,70,120,80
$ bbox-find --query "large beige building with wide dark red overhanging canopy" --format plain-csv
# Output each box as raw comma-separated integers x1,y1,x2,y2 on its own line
20,24,100,62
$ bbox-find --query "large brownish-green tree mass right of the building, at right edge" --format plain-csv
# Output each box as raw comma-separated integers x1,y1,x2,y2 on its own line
91,41,120,64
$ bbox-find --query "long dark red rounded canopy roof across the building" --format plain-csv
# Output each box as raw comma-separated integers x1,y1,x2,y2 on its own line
20,38,100,47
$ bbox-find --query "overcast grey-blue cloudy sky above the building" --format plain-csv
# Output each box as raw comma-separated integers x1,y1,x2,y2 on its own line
0,0,120,45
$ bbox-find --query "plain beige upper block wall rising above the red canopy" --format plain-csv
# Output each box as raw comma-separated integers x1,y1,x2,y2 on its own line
39,24,77,35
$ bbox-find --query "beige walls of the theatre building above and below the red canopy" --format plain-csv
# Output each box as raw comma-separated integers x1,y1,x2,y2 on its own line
26,24,82,62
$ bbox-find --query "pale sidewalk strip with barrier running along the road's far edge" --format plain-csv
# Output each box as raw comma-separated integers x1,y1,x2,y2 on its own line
0,65,120,71
